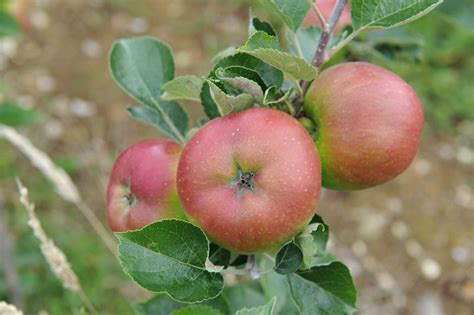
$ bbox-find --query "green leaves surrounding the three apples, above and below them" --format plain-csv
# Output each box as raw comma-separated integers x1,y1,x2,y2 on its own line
110,0,448,315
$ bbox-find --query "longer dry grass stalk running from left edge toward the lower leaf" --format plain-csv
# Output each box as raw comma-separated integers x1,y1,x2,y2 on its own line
0,124,117,255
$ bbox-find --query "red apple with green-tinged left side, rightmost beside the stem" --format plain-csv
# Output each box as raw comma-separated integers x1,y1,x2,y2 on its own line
304,62,423,190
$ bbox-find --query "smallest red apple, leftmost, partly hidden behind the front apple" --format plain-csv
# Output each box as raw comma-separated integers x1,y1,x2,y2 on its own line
107,140,184,232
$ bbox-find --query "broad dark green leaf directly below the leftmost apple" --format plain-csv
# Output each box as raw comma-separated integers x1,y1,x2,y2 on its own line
116,220,224,303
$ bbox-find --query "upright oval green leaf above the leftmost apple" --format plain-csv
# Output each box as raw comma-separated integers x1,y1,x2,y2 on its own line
109,36,188,143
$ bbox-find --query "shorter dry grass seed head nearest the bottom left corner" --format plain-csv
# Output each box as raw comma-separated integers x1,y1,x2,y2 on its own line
17,179,96,314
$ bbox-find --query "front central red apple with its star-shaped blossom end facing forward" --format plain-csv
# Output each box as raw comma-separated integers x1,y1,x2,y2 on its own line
178,108,321,253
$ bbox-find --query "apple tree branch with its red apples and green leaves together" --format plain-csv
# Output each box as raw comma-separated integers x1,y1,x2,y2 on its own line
108,0,442,315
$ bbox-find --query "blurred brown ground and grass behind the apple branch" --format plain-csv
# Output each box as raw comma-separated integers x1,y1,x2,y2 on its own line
0,0,474,315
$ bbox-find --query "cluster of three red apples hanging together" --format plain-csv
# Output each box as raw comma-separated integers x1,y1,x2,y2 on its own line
107,62,423,254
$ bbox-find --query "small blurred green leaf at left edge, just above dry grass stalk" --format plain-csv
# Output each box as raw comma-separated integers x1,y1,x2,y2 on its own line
0,101,43,127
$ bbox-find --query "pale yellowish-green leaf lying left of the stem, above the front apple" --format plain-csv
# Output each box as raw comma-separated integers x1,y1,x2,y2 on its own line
239,32,318,81
